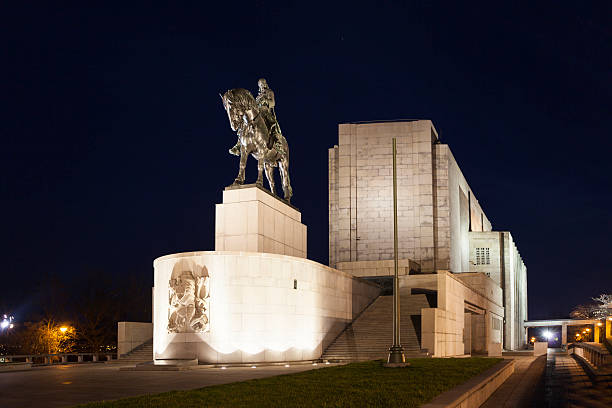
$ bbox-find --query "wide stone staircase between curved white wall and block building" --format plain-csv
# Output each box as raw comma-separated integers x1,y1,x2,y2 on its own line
321,294,432,361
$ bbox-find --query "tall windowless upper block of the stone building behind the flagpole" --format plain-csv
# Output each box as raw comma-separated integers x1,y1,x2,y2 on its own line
328,120,491,276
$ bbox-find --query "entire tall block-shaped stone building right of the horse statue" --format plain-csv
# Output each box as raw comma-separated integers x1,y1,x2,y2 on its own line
329,120,527,354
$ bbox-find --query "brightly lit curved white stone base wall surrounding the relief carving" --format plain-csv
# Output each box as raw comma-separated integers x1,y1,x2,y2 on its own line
153,251,379,363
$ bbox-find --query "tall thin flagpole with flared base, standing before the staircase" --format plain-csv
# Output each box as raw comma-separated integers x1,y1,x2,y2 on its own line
387,138,406,366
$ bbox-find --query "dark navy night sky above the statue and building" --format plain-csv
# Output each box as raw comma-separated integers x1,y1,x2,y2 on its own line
0,1,612,319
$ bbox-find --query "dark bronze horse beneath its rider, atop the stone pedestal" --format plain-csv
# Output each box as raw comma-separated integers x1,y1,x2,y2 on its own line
221,88,293,202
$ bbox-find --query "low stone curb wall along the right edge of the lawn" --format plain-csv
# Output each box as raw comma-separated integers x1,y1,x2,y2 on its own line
421,360,514,408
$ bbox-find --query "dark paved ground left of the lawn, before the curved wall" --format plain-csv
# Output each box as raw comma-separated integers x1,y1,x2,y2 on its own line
0,364,324,408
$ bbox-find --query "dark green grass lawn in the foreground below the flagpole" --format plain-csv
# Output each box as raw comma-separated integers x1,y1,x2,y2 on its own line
80,358,501,408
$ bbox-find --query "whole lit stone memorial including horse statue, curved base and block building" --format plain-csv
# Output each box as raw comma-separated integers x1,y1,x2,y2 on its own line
118,79,527,365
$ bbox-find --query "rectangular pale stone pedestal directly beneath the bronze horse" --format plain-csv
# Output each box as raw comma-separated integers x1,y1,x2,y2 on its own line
215,184,306,258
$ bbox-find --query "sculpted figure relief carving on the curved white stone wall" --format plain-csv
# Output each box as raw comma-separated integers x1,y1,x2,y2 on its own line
168,271,210,333
